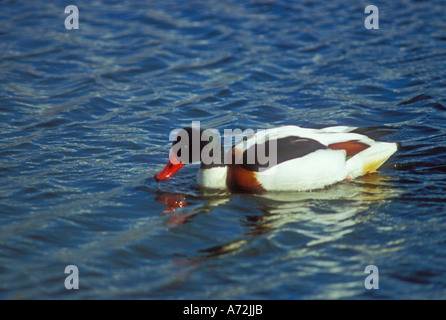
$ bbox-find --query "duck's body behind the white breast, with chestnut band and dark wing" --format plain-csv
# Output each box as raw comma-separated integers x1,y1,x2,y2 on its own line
227,126,397,192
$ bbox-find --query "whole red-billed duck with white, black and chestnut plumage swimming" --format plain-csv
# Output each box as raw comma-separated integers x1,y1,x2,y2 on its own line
155,125,398,193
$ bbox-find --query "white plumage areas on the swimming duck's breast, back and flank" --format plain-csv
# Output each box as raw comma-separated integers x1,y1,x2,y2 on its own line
197,126,397,191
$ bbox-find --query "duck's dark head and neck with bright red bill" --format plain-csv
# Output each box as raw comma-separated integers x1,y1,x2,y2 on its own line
155,127,223,181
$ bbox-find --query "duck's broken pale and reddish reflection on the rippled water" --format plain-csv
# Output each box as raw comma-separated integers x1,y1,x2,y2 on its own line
157,174,399,260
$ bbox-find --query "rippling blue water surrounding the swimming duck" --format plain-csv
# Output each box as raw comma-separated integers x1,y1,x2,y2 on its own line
0,0,446,299
